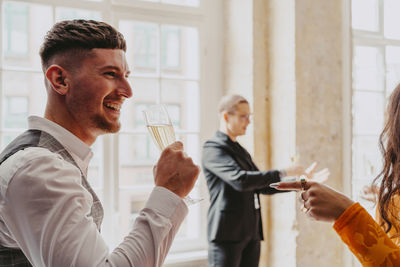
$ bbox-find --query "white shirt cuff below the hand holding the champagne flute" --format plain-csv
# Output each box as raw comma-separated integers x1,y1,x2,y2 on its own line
145,186,188,218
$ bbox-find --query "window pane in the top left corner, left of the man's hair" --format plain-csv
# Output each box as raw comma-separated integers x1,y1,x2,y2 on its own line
2,2,53,69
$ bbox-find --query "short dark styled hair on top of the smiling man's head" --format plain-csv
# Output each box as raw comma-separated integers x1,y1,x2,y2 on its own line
40,19,126,70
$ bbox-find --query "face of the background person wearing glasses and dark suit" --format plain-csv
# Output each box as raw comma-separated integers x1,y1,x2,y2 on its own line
227,103,251,136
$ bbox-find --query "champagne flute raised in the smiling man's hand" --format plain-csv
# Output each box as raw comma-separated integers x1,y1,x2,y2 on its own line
143,104,203,205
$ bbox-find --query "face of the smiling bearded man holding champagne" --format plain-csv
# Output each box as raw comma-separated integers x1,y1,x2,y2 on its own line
66,48,132,136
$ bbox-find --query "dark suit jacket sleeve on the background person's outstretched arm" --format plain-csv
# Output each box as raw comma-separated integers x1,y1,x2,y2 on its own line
202,142,280,194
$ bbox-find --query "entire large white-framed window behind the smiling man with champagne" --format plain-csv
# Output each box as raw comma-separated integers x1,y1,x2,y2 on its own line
0,0,219,264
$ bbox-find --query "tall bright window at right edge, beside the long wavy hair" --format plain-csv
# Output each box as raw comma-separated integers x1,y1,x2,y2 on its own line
352,0,400,213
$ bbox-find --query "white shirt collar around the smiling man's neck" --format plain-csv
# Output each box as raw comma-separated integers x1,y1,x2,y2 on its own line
28,116,93,175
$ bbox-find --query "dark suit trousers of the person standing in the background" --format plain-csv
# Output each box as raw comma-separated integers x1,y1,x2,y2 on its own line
208,240,260,267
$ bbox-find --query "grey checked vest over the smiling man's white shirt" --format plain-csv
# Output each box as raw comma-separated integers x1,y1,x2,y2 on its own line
0,130,104,267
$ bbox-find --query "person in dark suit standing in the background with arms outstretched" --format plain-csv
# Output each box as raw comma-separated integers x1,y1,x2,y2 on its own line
202,95,326,267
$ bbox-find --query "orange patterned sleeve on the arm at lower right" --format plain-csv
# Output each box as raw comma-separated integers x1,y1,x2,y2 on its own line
333,203,400,267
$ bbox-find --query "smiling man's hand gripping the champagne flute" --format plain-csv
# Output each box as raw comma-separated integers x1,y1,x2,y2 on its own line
153,142,200,198
